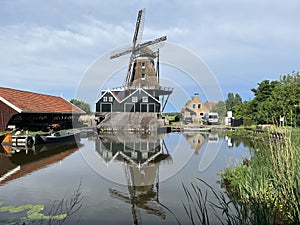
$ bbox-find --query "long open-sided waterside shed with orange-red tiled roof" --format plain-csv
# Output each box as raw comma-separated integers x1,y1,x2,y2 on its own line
0,87,85,131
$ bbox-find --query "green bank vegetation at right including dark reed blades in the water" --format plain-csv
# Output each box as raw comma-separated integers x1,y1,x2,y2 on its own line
183,128,300,225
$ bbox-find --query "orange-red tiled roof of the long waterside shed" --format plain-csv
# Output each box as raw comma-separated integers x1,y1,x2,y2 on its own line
0,87,85,114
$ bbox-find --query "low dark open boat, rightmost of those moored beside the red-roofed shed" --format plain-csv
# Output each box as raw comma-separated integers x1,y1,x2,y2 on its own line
33,132,80,145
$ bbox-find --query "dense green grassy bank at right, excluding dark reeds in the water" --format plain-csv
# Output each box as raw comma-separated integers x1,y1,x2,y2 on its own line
221,129,300,224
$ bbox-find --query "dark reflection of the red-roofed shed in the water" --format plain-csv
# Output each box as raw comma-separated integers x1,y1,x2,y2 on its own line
0,141,78,185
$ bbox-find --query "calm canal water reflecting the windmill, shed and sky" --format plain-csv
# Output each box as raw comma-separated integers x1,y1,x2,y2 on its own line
0,133,250,225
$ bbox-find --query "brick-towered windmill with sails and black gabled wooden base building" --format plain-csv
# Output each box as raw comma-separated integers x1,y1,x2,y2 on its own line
96,10,173,130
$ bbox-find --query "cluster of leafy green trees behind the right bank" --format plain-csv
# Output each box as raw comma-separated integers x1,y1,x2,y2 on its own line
226,72,300,126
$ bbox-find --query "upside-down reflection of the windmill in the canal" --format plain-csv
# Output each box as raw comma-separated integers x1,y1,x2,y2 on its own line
96,134,172,224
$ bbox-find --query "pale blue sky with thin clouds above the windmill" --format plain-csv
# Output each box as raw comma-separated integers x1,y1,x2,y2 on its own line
0,0,300,110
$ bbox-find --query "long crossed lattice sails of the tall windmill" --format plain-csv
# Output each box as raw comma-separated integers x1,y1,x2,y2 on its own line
110,9,167,86
